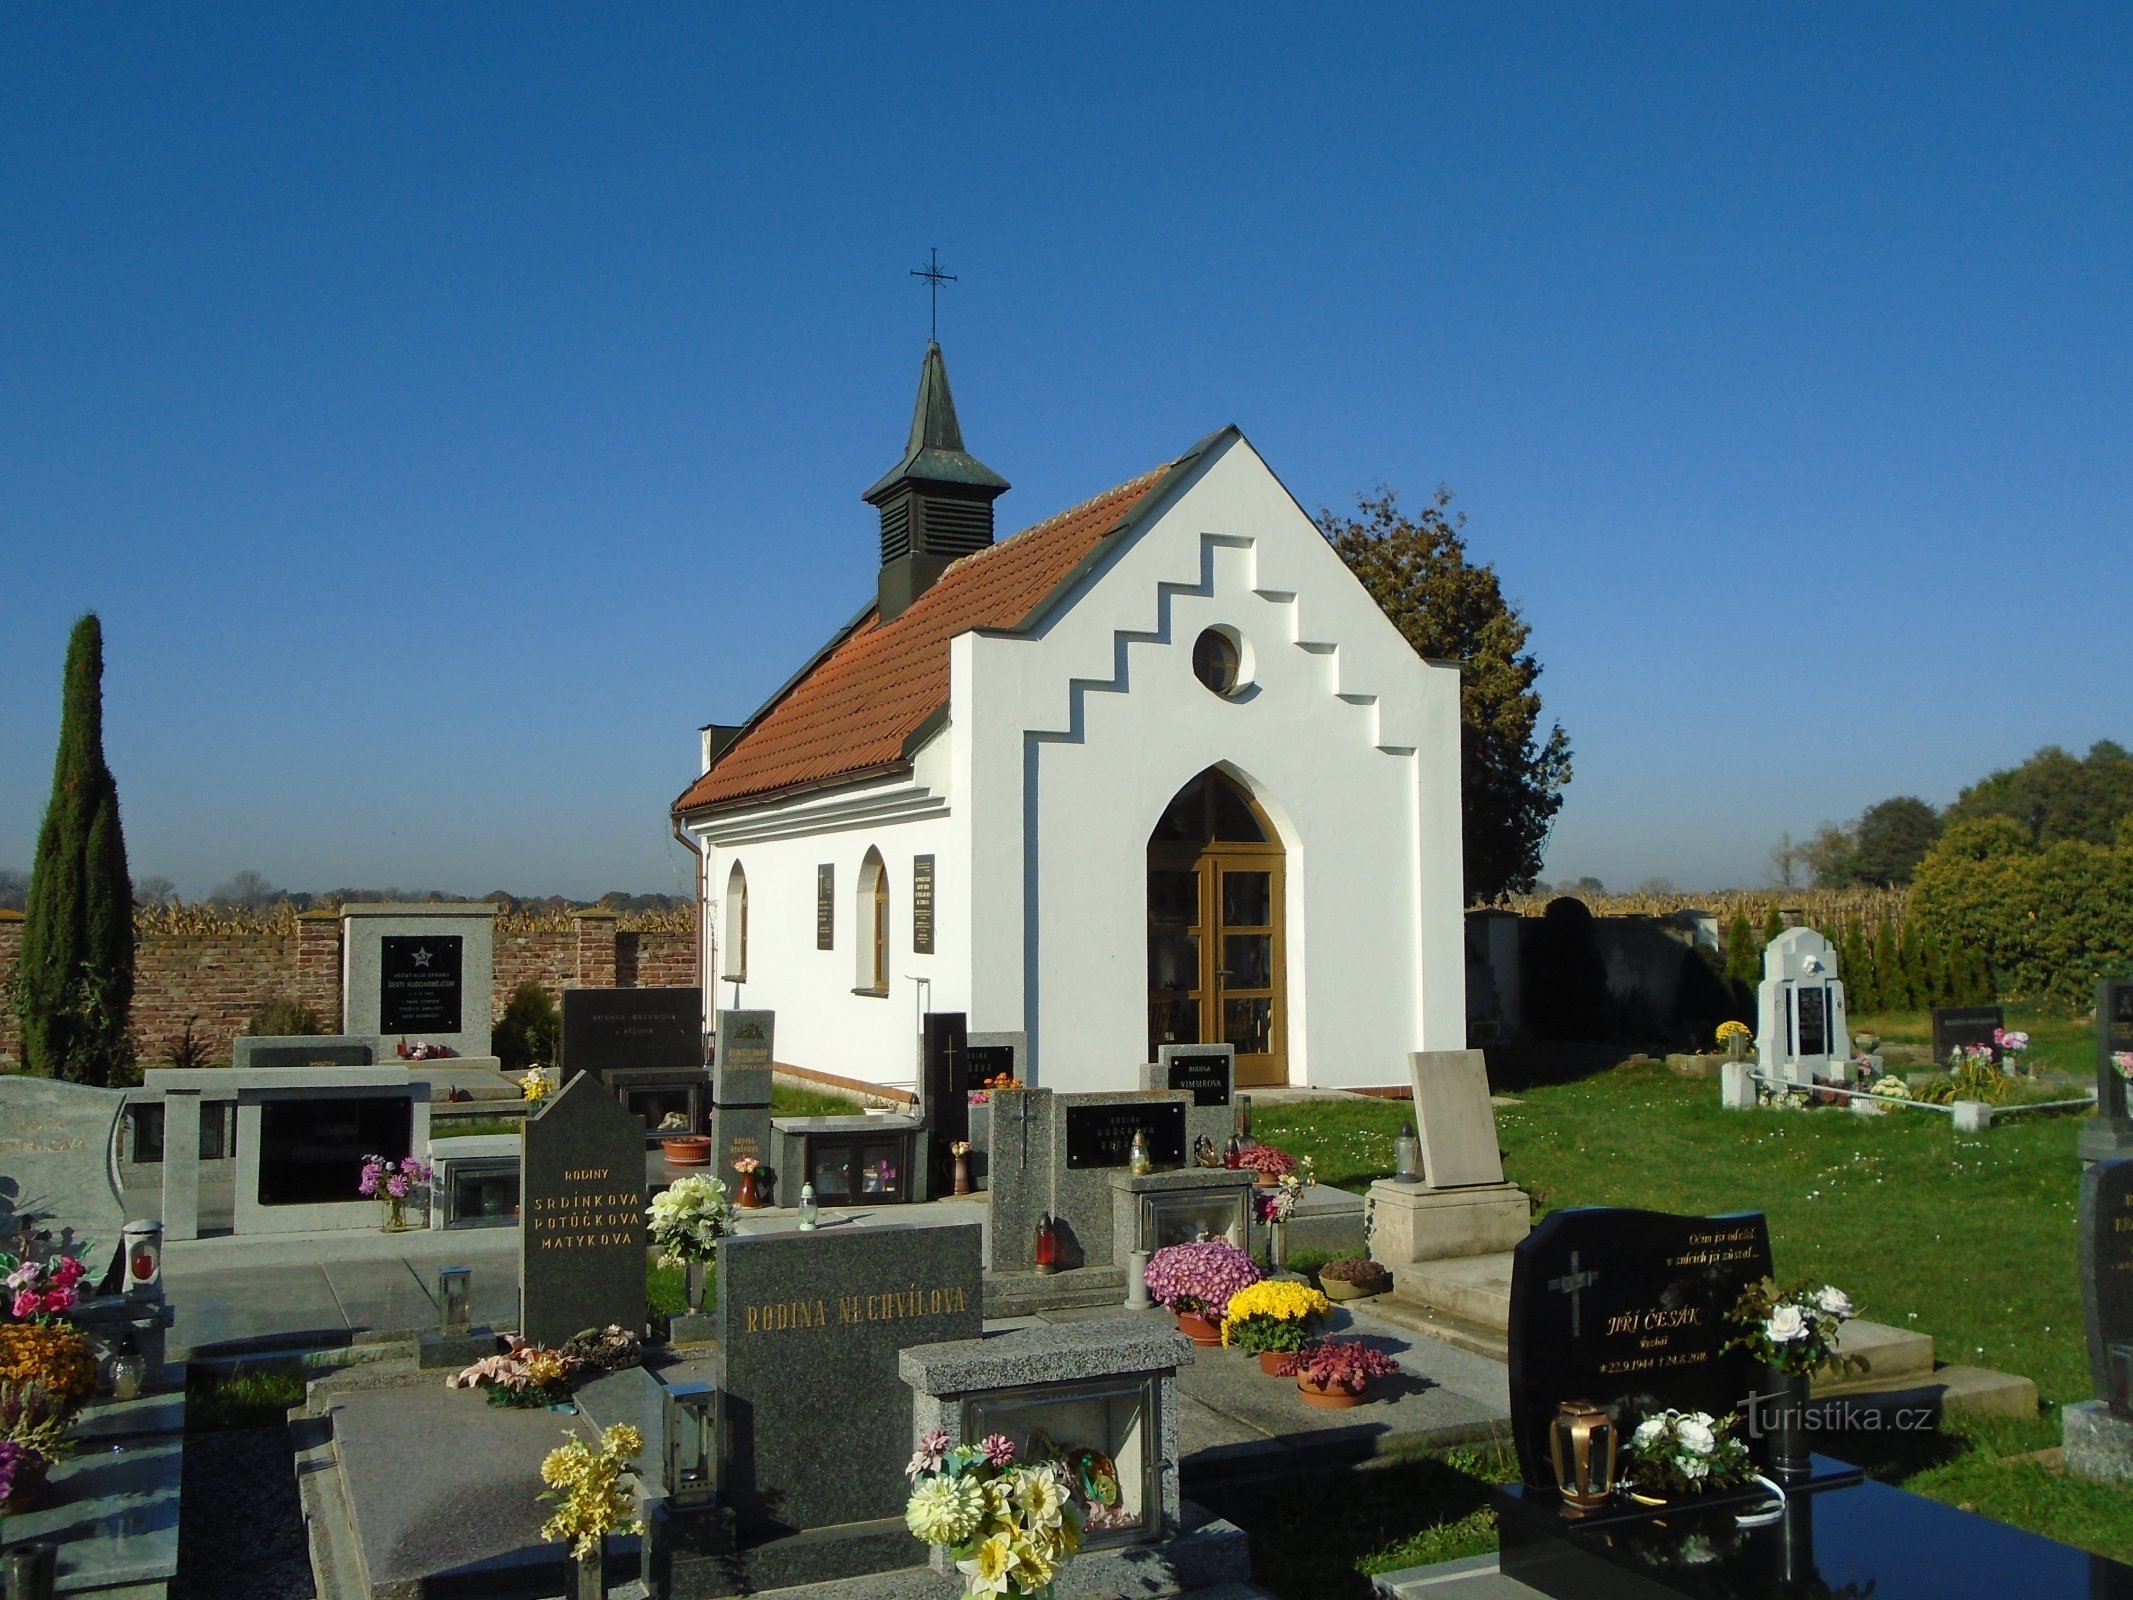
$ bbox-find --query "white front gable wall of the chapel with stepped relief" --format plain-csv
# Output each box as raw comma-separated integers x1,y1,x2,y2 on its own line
945,435,1465,1090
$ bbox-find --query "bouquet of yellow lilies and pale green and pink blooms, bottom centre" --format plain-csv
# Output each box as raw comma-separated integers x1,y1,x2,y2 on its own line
904,1429,1081,1600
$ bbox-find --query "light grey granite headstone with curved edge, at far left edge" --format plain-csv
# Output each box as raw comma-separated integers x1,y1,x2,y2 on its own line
0,1073,126,1284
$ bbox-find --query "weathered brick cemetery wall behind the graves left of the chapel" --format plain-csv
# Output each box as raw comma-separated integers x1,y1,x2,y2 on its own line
0,905,697,1073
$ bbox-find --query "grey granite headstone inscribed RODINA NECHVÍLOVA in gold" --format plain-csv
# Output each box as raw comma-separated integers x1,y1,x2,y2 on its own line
719,1222,983,1555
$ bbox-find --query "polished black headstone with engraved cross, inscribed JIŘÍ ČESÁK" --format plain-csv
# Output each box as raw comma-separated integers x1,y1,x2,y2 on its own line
1510,1207,1770,1485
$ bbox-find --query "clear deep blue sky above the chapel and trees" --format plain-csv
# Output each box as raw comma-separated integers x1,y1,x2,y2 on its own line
0,4,2133,896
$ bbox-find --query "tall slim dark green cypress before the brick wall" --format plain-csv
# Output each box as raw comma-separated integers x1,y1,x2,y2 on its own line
15,612,134,1086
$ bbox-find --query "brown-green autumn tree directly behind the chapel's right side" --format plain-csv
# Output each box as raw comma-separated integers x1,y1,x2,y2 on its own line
1318,486,1570,905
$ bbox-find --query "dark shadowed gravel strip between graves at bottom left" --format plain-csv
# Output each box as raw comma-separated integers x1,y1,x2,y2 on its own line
171,1427,316,1600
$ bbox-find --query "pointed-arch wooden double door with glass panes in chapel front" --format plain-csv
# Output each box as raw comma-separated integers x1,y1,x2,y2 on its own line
1148,768,1288,1088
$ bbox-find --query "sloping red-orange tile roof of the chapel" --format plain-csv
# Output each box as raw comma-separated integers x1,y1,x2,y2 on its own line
674,463,1177,813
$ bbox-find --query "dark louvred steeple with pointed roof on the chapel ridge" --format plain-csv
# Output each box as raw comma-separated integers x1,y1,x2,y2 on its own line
862,343,1009,623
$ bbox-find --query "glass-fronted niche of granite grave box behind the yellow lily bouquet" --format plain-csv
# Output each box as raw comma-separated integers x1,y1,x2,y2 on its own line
962,1374,1162,1545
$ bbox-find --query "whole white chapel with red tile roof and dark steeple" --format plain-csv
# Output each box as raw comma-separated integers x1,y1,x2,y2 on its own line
674,343,1465,1090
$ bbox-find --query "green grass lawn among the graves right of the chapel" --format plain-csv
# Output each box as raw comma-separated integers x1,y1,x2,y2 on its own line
1239,1007,2133,1600
